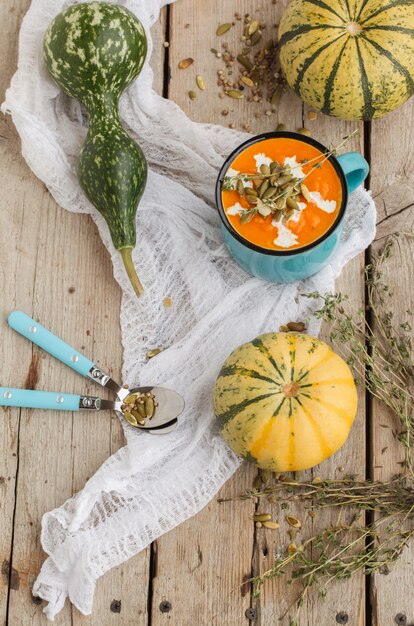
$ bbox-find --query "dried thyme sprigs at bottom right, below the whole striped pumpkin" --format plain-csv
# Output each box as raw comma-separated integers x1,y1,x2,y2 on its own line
240,476,414,626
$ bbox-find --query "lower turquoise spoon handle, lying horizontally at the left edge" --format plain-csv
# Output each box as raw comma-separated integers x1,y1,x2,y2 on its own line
0,387,81,411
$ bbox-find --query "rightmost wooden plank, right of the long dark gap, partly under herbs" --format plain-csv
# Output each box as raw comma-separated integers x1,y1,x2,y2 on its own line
371,99,414,626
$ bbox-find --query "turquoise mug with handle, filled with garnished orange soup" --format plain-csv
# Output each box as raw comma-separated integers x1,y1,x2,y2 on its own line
216,132,369,282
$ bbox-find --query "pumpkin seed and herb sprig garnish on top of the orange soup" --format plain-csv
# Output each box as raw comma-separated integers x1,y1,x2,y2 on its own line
222,130,358,224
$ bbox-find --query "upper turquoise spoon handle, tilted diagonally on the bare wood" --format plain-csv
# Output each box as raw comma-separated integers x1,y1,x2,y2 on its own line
8,311,95,376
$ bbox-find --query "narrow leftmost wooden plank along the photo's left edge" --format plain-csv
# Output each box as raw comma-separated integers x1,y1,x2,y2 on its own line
0,0,47,624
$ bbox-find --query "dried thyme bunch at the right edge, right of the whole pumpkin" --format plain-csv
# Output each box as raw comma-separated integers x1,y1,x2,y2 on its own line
303,235,414,473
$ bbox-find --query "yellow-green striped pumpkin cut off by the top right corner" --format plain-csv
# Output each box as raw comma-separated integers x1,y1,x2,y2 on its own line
279,0,414,120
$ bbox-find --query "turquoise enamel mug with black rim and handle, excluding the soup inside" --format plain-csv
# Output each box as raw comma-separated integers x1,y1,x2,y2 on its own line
216,132,369,283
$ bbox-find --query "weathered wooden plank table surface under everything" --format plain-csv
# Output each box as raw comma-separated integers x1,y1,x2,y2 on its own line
0,0,414,626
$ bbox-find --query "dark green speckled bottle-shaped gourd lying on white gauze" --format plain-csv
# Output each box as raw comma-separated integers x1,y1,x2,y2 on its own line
44,2,147,295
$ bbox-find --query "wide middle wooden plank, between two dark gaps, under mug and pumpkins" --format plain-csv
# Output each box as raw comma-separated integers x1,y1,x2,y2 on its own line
151,0,365,626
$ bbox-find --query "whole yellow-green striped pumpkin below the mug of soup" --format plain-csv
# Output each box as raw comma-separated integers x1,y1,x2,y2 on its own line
214,333,358,472
